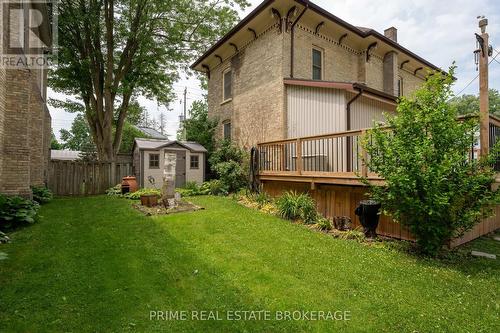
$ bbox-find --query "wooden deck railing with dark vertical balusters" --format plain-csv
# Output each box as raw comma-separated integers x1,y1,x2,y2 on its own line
258,116,500,178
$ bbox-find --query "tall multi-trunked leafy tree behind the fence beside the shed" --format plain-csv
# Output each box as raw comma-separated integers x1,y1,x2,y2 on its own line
49,0,249,160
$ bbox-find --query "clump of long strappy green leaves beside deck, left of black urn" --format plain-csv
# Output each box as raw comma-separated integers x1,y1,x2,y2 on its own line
276,191,318,224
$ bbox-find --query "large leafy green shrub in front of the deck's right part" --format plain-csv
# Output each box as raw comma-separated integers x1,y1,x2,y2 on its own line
362,67,500,254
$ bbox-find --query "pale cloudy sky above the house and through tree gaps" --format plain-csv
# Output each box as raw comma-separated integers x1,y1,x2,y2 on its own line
49,0,500,139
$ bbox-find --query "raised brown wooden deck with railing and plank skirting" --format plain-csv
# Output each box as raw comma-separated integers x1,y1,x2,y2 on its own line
257,116,500,247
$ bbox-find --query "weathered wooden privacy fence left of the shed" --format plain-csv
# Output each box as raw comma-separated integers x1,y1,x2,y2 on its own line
48,160,133,196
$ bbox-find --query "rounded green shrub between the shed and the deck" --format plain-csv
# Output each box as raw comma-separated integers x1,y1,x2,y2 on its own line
210,141,249,193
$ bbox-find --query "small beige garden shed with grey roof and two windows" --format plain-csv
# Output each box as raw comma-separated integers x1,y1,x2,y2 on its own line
133,139,207,188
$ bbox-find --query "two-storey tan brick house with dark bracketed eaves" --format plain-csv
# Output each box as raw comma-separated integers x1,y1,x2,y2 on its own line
192,0,439,148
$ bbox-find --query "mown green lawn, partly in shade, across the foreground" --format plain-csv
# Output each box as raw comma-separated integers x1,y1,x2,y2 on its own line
0,197,500,332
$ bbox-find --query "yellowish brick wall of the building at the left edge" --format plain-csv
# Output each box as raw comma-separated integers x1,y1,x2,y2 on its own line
0,1,52,197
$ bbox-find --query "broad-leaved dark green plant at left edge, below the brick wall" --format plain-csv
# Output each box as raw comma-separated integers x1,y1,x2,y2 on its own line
0,194,40,229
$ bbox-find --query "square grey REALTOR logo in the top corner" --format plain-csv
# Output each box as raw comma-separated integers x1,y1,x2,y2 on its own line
0,0,58,68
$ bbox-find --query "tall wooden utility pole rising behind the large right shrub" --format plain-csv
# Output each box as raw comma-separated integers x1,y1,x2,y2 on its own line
476,17,490,156
